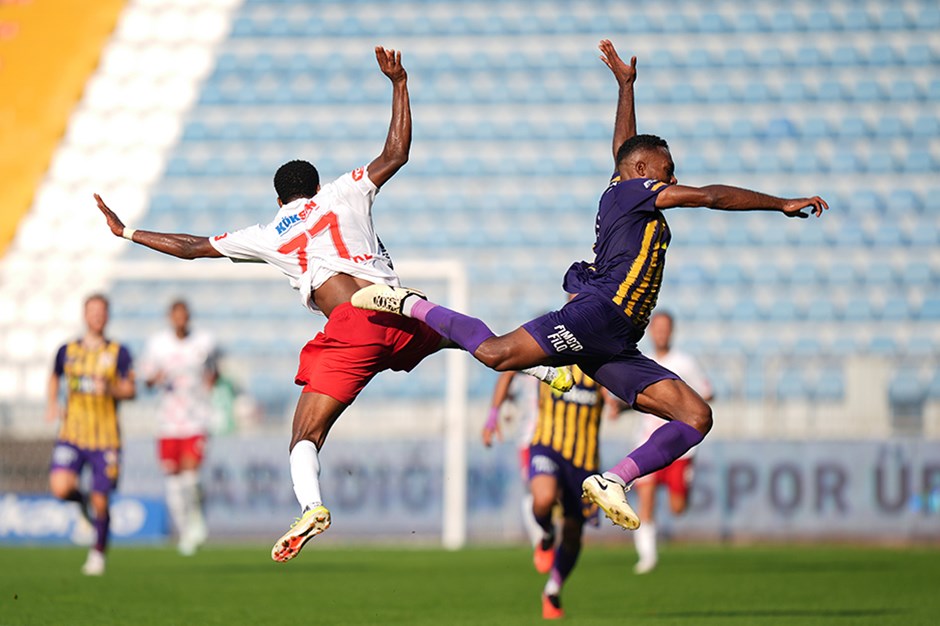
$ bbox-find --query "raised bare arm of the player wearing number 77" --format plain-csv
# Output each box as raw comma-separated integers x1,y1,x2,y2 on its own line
369,46,411,187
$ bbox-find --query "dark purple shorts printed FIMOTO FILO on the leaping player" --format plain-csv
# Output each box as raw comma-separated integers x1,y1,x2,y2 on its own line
522,293,680,406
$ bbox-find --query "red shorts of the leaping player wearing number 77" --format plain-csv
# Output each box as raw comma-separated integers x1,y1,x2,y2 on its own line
294,302,441,404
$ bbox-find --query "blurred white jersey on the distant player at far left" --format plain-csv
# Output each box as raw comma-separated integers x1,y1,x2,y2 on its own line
141,330,216,439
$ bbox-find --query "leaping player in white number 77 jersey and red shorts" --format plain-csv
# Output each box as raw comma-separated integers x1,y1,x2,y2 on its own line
95,47,572,562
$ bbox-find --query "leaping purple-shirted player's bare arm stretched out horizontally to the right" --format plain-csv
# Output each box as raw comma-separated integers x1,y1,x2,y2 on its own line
656,185,829,218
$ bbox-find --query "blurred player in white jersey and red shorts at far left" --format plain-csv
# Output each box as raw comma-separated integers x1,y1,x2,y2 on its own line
141,300,218,556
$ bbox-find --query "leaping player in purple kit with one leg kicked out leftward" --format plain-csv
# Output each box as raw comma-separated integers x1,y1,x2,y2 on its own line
352,39,829,530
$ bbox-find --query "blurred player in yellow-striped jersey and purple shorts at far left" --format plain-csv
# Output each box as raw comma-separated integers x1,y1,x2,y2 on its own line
46,294,136,576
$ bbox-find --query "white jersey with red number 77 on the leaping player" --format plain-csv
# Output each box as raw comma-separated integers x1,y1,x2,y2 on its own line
209,167,401,312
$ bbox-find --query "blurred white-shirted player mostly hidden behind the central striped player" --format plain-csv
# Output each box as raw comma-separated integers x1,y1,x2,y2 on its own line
483,372,544,544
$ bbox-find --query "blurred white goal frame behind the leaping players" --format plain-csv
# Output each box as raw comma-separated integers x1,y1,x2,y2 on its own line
111,259,469,550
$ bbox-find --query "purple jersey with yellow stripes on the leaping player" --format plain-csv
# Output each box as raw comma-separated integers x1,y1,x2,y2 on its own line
564,177,671,331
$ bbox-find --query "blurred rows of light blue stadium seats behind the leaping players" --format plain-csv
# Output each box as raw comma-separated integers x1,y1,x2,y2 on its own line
116,0,940,401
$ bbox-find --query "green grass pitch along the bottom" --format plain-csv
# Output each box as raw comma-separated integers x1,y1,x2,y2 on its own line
0,544,940,626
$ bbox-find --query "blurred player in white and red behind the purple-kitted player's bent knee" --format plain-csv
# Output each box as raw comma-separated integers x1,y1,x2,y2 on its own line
633,311,714,574
